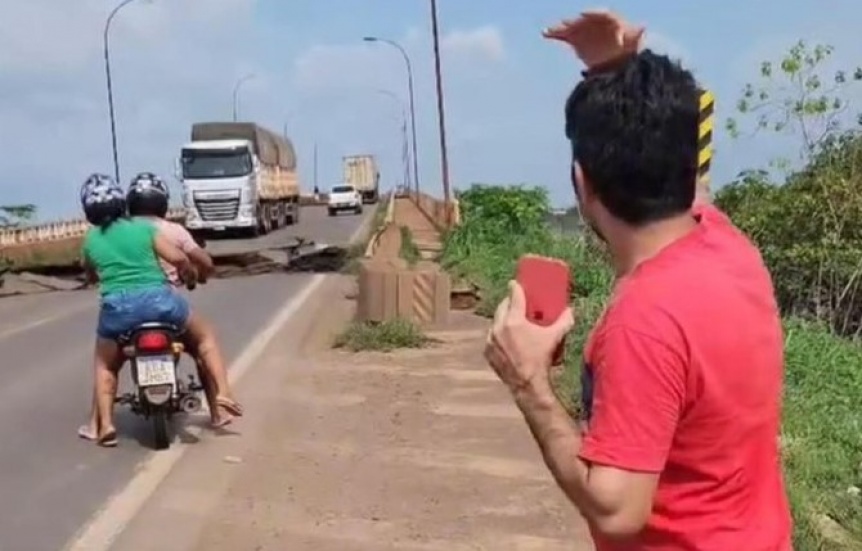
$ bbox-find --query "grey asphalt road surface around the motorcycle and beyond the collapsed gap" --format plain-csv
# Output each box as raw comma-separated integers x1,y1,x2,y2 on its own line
0,207,373,551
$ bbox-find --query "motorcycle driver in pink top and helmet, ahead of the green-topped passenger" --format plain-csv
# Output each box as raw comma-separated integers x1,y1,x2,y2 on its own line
126,172,242,427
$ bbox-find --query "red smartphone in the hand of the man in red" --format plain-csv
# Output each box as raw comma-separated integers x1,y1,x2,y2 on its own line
515,254,572,366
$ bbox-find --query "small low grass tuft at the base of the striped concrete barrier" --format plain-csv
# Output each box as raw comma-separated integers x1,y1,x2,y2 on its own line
333,319,432,352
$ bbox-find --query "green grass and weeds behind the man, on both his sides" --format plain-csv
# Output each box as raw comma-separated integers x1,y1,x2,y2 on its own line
443,187,862,551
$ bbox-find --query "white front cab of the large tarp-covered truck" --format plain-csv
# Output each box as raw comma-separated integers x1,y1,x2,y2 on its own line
179,140,260,231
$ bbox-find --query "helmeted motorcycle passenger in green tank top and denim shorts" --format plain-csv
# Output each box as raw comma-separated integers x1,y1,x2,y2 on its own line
78,174,242,446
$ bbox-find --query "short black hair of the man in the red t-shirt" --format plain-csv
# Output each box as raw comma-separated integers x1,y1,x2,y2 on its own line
566,50,699,226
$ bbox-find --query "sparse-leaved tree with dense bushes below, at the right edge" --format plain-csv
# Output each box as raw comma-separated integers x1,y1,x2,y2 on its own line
716,41,862,334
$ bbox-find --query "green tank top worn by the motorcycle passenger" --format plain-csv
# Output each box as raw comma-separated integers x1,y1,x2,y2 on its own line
83,218,168,296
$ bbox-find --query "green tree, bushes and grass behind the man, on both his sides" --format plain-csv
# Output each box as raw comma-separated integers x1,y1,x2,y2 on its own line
443,43,862,551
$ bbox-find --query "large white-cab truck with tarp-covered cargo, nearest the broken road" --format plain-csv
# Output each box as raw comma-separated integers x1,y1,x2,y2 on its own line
178,122,300,237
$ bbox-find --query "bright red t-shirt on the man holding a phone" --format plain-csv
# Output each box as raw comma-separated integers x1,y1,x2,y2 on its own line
580,206,791,551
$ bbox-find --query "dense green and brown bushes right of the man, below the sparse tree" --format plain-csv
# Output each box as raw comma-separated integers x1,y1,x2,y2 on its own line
716,133,862,337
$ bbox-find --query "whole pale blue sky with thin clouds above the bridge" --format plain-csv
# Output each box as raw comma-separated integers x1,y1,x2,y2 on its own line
0,0,862,218
